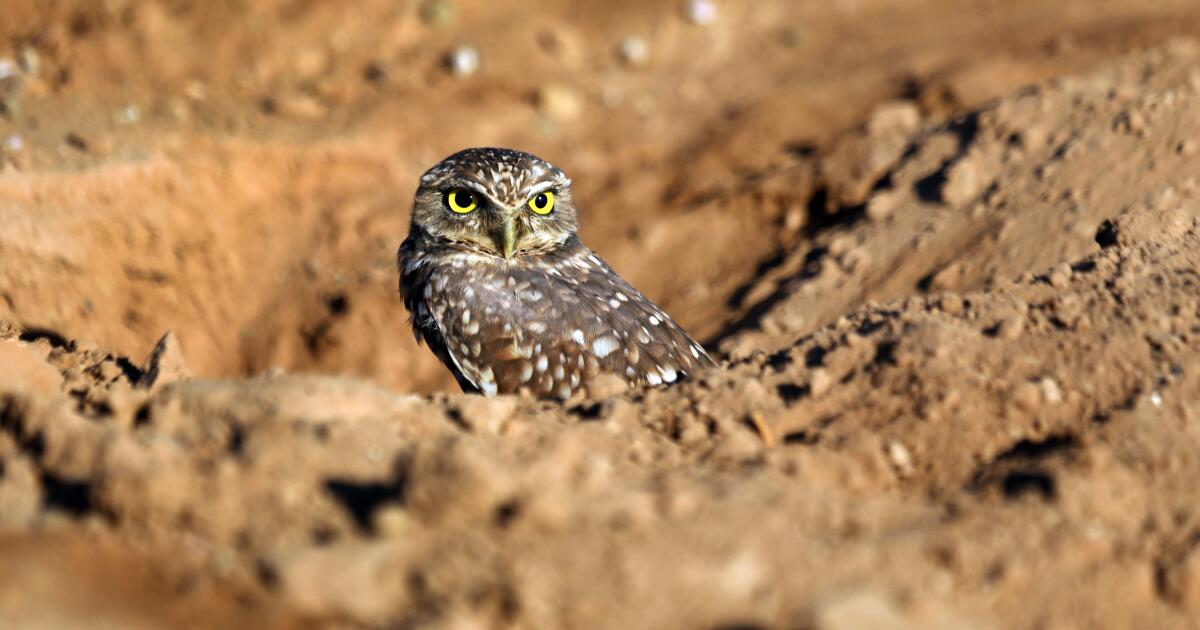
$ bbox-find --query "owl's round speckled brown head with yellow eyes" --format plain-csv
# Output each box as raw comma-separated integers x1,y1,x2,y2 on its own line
413,149,578,260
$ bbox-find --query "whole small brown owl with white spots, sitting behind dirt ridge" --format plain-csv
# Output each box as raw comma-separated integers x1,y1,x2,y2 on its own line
398,149,713,400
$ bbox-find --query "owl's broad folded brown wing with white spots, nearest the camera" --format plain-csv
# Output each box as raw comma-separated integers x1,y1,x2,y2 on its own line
433,251,713,398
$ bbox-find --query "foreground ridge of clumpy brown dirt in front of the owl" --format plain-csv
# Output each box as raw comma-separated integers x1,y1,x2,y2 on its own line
0,205,1200,628
